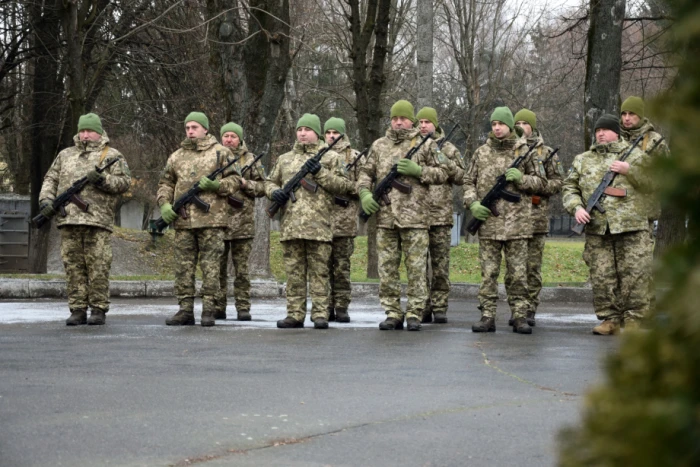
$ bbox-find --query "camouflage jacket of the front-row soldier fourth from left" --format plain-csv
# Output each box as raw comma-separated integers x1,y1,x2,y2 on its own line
357,128,448,229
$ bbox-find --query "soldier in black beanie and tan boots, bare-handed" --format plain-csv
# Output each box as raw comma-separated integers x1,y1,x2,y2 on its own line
563,114,653,335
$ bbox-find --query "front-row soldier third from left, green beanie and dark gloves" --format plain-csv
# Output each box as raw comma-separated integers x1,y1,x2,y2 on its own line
265,114,354,329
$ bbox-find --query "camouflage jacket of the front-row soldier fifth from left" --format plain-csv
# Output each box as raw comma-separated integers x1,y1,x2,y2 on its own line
464,133,546,241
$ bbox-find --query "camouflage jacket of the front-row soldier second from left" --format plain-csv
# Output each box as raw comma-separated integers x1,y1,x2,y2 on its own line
156,135,240,229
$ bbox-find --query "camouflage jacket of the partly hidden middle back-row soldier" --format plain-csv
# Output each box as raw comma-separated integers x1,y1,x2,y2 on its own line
428,129,465,226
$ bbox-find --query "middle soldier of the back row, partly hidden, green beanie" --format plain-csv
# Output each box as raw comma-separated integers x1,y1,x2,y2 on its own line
416,107,464,323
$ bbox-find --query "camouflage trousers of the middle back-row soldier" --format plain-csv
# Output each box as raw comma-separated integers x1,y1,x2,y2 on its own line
428,225,452,313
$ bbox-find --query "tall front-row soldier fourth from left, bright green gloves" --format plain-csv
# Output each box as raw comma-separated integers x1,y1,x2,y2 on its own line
357,100,448,331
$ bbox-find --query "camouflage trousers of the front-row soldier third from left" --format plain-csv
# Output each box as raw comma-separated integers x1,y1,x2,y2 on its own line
280,240,332,321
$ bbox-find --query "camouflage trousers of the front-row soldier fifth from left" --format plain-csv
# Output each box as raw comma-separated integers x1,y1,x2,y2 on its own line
479,238,529,318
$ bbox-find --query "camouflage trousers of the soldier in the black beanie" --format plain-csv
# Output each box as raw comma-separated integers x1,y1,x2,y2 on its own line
583,230,652,322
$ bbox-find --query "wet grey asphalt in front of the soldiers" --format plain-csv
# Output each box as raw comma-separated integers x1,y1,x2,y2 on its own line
0,299,619,467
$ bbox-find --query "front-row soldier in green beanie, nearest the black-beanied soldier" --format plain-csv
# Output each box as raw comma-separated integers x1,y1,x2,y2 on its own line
464,107,544,334
